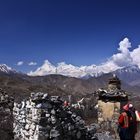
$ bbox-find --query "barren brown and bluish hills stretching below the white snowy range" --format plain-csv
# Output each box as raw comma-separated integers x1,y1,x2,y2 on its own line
0,63,140,98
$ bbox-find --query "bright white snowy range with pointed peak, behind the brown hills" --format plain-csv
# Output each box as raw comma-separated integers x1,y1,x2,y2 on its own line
28,60,114,78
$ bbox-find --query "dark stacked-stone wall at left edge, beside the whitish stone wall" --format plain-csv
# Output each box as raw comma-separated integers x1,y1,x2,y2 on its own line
0,89,14,140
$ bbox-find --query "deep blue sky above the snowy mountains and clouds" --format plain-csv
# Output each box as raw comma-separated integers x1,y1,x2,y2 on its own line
0,0,140,72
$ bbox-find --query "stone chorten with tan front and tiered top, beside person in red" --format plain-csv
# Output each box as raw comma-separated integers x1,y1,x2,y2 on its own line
96,75,128,140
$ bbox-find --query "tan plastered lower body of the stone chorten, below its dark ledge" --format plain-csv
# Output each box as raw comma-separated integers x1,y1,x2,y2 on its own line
98,100,121,139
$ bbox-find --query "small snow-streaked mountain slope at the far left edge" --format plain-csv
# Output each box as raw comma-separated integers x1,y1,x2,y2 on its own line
0,64,18,74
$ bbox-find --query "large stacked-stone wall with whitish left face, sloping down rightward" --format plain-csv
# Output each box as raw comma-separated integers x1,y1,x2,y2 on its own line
13,92,97,140
